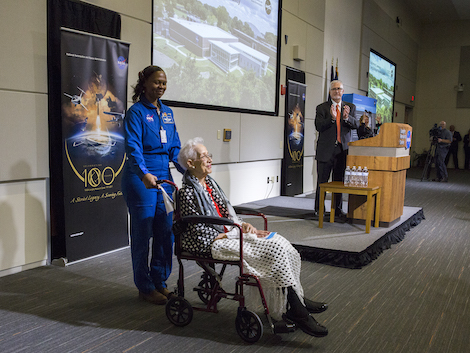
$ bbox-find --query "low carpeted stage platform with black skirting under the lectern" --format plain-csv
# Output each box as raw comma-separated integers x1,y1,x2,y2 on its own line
235,195,424,268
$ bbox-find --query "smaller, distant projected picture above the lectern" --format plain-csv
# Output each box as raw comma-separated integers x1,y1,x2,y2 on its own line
369,51,396,123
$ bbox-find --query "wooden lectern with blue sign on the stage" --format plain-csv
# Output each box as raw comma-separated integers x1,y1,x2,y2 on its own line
346,123,412,227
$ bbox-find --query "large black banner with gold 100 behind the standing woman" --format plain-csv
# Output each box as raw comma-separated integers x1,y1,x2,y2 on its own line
61,29,129,261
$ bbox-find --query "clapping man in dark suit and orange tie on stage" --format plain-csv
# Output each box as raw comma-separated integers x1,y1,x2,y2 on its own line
315,80,359,220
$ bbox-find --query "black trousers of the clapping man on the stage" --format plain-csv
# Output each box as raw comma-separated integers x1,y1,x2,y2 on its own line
315,144,348,212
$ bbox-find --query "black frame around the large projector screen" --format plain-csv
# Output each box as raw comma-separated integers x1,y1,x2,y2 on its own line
151,0,282,116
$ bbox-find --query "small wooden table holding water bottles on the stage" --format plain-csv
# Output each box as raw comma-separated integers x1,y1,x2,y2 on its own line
318,181,381,233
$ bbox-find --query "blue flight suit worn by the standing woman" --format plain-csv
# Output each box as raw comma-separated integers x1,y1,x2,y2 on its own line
122,95,184,294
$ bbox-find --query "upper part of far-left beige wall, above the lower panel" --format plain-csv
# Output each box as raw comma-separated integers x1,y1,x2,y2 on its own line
0,0,49,181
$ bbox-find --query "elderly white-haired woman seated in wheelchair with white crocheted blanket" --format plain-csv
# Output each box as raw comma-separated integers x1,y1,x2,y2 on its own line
174,138,328,337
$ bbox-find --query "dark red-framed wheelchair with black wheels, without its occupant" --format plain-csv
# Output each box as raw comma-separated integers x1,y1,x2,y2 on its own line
158,180,296,343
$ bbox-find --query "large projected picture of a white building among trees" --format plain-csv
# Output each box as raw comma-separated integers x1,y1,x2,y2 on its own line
152,0,279,112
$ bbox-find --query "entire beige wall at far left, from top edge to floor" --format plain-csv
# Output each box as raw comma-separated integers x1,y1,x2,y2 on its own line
0,0,49,275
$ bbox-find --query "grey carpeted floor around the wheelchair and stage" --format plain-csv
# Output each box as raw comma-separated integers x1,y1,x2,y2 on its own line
0,166,470,353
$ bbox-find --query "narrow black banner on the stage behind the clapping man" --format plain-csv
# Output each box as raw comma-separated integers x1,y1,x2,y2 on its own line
281,80,306,196
